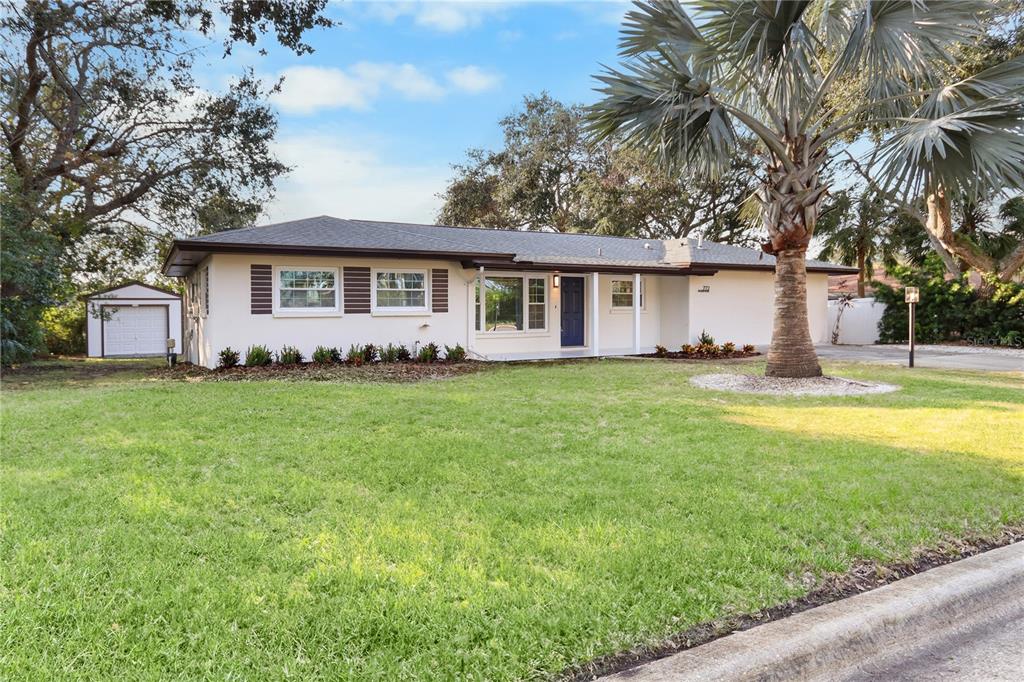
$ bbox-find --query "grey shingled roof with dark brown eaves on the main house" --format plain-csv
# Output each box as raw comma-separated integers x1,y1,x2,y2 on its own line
164,215,856,276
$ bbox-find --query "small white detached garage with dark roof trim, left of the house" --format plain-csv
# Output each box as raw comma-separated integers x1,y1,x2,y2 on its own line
85,282,181,357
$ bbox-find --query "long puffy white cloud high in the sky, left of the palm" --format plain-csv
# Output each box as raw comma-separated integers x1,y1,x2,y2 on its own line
270,61,501,115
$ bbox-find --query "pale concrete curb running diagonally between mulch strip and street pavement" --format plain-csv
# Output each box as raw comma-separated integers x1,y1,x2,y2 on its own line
601,542,1024,682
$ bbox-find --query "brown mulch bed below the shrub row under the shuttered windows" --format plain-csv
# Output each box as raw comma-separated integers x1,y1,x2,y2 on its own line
152,360,486,383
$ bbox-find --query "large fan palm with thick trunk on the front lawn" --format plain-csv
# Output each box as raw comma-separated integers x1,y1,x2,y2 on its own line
589,0,1024,377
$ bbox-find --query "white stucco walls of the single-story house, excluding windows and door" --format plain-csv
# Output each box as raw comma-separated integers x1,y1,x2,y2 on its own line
185,254,828,360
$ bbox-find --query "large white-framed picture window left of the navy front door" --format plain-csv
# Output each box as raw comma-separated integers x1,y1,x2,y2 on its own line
476,275,548,332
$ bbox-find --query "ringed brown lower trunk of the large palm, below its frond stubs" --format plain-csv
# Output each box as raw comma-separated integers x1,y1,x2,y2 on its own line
765,249,821,378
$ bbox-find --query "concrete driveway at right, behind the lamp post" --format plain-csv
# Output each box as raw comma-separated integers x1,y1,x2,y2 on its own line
815,345,1024,372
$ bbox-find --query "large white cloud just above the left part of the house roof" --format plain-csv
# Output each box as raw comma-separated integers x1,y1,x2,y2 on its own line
267,130,451,223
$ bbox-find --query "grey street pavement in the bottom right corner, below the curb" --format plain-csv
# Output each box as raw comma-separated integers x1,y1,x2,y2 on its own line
847,601,1024,682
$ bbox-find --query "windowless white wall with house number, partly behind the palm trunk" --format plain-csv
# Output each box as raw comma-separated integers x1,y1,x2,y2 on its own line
687,270,828,345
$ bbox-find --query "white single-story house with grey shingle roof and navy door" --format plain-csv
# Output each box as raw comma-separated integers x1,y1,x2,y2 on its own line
163,216,856,367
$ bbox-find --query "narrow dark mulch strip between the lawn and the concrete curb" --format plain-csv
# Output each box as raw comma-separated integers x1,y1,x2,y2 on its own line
563,525,1024,682
